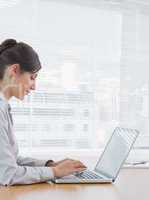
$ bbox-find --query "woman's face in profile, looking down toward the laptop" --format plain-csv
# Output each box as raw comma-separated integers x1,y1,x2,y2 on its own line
12,72,38,100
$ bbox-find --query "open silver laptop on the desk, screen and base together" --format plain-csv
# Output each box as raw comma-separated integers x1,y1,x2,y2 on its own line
52,127,139,183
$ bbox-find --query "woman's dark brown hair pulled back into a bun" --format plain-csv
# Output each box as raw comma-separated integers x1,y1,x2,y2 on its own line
0,39,41,79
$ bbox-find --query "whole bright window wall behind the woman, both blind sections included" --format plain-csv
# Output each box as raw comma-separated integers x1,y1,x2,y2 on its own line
0,0,149,151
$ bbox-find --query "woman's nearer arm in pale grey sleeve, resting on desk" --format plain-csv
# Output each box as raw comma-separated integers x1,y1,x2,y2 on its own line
0,112,54,185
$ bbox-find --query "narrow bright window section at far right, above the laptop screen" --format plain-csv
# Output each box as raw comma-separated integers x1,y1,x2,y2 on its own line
120,8,149,149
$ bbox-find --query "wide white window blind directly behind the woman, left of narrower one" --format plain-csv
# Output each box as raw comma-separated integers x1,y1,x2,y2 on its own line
0,0,121,151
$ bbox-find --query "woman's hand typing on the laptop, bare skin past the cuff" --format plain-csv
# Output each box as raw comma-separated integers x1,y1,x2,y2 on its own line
52,159,86,177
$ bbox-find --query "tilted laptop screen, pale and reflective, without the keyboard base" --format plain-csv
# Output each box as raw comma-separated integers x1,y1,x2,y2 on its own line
95,127,139,180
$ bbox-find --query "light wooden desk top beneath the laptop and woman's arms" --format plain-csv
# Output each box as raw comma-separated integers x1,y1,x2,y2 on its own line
0,169,149,200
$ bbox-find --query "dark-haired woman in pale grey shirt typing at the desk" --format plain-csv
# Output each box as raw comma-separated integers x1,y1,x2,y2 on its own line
0,39,85,185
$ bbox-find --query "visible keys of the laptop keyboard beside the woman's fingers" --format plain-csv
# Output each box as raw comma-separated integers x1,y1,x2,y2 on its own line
75,170,103,179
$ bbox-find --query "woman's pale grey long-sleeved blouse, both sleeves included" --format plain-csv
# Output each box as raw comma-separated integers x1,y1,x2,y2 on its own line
0,93,54,186
